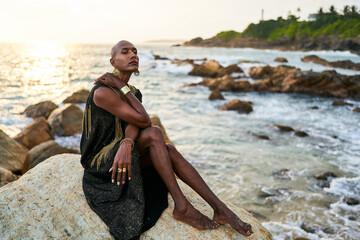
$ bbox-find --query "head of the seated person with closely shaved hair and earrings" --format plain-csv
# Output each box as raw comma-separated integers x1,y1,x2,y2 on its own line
110,41,139,72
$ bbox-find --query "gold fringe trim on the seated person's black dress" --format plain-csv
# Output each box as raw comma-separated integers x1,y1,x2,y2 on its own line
89,85,136,169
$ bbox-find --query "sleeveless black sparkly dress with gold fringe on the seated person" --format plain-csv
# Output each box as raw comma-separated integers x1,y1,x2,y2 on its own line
80,83,168,239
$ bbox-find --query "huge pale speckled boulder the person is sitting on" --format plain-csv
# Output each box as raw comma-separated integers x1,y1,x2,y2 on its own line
0,154,272,240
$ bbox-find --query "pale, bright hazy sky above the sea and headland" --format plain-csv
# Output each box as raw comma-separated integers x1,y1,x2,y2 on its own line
0,0,360,43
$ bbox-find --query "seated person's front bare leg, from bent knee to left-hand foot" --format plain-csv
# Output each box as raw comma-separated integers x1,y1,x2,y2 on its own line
137,127,218,229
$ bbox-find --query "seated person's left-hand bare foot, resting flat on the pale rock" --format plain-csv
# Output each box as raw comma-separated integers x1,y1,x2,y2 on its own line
173,203,219,230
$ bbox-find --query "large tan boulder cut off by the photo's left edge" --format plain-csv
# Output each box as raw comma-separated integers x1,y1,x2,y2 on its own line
0,129,28,172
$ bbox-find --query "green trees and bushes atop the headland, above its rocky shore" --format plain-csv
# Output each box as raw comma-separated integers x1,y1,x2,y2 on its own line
216,6,360,41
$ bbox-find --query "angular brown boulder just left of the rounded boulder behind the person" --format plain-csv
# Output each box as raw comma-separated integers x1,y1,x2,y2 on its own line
14,117,54,149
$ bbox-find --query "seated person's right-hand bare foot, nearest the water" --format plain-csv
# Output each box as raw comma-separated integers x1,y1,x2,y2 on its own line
213,206,254,236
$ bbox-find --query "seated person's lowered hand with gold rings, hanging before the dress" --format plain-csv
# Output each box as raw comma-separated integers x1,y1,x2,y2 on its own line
109,141,132,185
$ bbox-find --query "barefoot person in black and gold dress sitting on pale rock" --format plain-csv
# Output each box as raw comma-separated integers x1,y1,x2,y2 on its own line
80,40,253,239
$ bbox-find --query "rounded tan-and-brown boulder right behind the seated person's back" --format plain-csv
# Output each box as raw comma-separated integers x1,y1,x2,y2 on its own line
48,104,83,136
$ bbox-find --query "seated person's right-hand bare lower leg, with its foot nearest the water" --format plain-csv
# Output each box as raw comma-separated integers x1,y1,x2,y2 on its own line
166,144,252,236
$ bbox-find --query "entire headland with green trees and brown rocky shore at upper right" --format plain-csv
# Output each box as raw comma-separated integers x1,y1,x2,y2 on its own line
184,5,360,53
